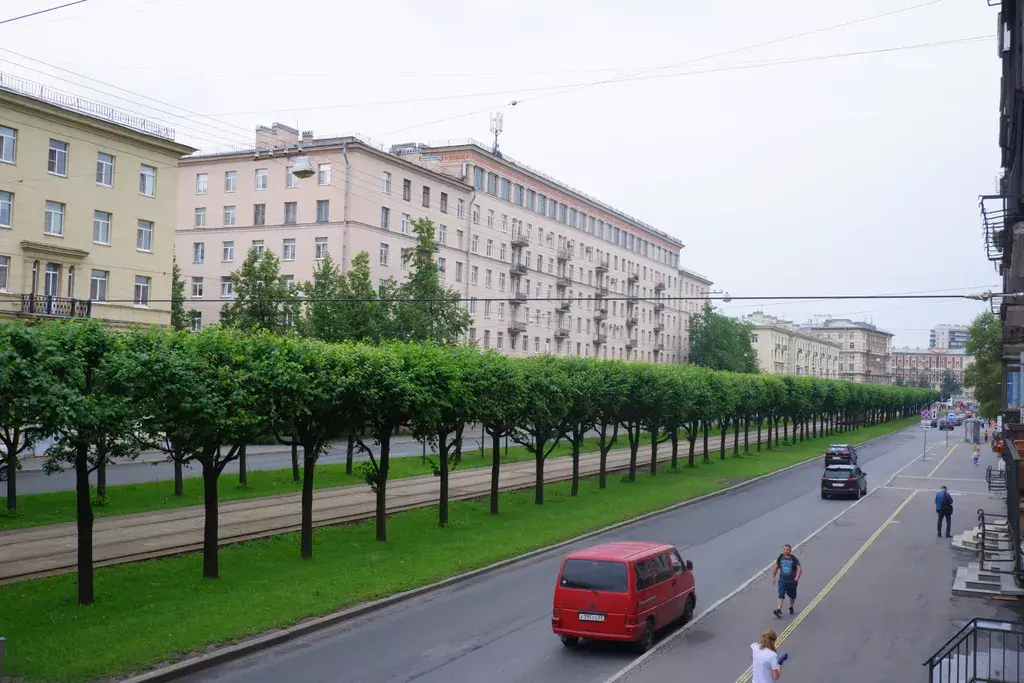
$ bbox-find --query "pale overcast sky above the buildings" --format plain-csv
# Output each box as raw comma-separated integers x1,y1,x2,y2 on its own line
0,0,1000,346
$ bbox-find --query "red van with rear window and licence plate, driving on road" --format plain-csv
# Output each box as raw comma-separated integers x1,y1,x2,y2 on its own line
551,542,696,652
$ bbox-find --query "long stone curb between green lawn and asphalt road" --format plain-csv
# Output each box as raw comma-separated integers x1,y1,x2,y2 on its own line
122,425,916,683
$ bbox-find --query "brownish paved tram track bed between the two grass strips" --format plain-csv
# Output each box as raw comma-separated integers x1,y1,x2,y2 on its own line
0,421,827,584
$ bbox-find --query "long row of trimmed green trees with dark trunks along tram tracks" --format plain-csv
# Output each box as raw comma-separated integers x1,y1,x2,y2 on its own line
0,322,935,603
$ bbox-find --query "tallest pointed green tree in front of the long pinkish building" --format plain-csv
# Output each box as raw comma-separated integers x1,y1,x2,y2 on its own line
386,218,472,345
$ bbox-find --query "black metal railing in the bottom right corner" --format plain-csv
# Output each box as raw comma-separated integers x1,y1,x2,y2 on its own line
924,618,1024,683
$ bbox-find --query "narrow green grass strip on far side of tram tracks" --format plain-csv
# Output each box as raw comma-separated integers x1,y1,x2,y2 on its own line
0,436,650,531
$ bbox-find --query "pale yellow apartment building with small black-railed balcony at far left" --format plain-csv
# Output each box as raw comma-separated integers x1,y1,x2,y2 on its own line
0,74,195,326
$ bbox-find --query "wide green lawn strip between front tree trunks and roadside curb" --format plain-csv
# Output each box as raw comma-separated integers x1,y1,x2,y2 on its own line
0,418,918,681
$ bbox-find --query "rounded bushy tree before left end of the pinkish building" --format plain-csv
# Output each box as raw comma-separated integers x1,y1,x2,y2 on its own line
221,247,298,335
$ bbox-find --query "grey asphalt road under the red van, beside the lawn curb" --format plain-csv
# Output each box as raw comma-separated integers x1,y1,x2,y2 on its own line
178,429,944,683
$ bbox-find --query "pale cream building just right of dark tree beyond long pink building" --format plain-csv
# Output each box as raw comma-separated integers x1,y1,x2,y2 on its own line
743,311,842,379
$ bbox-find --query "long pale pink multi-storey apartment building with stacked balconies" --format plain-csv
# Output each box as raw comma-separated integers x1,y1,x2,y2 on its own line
176,124,688,362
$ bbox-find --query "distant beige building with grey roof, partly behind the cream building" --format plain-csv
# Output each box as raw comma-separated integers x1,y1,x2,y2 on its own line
800,318,893,384
